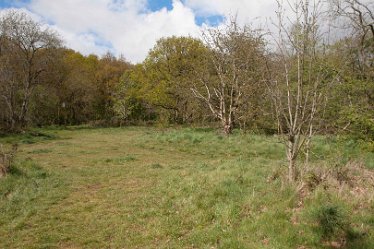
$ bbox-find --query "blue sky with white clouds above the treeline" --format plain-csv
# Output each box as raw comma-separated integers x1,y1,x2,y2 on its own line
0,0,276,63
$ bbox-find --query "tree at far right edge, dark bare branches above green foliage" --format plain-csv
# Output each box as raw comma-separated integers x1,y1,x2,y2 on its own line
330,0,374,140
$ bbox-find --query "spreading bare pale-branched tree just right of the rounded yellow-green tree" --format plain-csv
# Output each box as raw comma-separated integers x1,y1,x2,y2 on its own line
191,21,265,135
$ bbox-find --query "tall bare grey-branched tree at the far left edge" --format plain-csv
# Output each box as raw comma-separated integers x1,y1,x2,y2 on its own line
0,11,61,131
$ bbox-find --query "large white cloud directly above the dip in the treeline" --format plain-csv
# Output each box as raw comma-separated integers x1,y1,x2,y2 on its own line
21,0,199,62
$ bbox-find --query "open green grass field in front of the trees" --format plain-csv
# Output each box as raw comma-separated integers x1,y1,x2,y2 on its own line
0,127,374,249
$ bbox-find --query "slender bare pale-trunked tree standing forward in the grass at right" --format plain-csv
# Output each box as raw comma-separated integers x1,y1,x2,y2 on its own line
266,0,334,182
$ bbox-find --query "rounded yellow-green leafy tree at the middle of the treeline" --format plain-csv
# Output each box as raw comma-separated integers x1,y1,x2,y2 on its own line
144,37,207,123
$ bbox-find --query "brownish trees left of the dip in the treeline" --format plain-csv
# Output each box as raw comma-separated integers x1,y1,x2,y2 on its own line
0,11,132,131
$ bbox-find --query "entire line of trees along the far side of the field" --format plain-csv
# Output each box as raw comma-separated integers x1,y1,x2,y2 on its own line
0,0,374,139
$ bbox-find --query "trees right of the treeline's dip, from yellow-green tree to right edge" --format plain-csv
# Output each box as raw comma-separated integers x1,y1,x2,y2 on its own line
115,0,374,140
